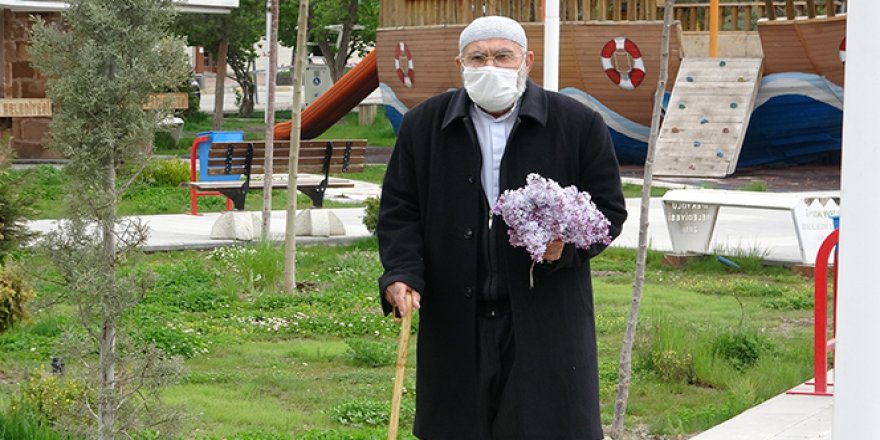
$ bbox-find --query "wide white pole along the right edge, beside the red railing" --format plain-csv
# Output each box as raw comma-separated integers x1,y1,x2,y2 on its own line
832,0,880,440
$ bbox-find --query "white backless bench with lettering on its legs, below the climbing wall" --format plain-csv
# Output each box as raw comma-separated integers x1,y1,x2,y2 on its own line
663,189,840,265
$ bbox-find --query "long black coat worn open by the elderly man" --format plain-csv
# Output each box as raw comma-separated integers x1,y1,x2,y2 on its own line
378,82,626,440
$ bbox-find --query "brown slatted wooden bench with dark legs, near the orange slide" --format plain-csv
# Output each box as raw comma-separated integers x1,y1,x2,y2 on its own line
189,136,367,215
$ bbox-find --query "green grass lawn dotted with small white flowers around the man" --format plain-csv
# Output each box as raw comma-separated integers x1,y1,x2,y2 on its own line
0,239,824,440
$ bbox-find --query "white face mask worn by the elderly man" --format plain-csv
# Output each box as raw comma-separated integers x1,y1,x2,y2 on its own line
461,60,527,113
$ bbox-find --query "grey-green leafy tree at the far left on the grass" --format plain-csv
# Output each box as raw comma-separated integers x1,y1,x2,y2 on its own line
30,0,190,440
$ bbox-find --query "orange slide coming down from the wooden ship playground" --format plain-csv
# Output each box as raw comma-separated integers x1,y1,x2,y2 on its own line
275,50,379,140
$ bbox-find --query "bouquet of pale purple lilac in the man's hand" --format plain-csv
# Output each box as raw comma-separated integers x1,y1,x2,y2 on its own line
492,173,611,263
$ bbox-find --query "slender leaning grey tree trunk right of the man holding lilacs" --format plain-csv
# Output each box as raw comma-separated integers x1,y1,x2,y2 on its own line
610,0,675,439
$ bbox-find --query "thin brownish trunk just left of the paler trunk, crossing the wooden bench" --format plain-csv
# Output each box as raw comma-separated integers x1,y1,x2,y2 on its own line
261,0,278,240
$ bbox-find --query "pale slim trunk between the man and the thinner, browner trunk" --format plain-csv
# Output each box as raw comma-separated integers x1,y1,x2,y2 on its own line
284,0,309,292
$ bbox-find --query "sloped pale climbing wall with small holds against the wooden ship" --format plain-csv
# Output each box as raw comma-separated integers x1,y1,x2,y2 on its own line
654,58,763,177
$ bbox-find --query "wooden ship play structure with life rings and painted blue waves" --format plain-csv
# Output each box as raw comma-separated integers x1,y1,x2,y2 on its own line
375,0,846,176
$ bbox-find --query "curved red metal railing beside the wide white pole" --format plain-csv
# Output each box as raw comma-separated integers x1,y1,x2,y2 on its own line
788,229,840,396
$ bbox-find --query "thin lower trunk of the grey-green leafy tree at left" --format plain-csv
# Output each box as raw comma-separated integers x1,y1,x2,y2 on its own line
98,157,119,440
